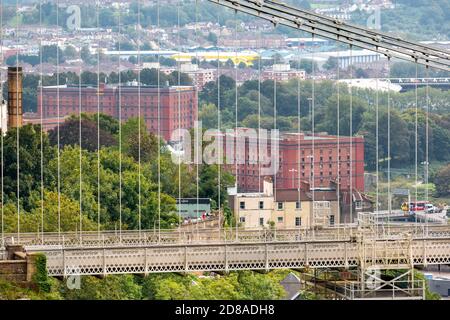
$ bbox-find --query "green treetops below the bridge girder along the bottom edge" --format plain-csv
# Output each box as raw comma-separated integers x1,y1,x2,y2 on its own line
0,270,298,300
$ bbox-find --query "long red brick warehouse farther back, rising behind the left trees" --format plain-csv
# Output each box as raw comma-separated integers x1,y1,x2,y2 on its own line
37,84,198,140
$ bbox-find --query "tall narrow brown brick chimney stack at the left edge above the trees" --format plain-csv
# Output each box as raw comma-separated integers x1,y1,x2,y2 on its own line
8,67,23,129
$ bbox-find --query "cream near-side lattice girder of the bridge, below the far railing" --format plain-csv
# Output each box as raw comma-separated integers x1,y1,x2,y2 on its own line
22,238,450,276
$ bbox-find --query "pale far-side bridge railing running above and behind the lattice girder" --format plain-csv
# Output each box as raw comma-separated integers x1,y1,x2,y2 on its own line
0,224,450,248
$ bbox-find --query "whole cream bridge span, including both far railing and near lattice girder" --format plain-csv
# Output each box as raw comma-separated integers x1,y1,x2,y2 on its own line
3,225,450,276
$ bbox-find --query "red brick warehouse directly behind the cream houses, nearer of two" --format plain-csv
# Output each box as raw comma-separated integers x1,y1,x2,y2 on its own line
227,133,364,192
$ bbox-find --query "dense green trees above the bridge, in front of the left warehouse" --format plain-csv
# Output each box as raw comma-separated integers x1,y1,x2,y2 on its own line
2,114,234,232
